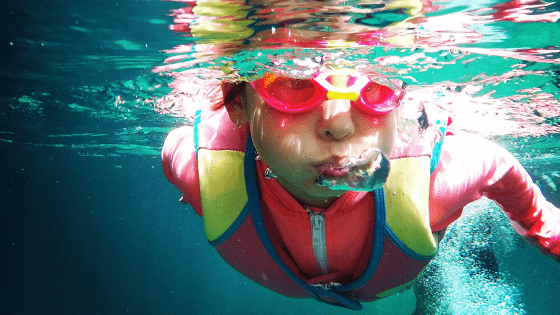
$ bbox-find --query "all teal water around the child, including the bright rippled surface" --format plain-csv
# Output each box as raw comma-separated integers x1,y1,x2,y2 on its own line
4,0,560,315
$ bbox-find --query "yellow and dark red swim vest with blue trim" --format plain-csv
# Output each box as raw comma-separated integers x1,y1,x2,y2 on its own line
195,106,447,310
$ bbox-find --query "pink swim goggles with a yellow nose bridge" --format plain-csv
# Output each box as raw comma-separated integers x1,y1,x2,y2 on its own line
251,73,404,115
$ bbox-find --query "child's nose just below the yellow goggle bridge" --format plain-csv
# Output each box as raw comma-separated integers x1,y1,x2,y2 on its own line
319,100,355,141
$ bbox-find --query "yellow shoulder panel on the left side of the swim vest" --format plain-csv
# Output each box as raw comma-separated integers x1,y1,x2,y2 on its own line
198,149,248,241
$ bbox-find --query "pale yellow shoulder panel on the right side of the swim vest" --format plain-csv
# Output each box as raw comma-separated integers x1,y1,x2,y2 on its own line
385,156,437,256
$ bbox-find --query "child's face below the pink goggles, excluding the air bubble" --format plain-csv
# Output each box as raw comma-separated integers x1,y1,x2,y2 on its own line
241,76,398,207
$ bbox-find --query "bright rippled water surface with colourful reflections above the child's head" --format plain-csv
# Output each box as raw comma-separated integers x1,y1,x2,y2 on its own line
154,0,560,136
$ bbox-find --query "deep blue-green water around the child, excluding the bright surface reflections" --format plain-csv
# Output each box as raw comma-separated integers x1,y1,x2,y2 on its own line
0,1,560,315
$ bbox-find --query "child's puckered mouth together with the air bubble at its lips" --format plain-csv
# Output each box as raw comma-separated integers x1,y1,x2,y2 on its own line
315,149,389,191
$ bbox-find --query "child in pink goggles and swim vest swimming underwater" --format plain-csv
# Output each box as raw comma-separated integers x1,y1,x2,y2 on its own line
162,70,560,309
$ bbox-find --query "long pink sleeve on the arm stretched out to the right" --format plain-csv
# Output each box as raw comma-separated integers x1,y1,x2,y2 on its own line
430,134,560,258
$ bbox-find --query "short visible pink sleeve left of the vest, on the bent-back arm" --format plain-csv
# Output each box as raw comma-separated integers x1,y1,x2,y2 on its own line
161,126,202,216
